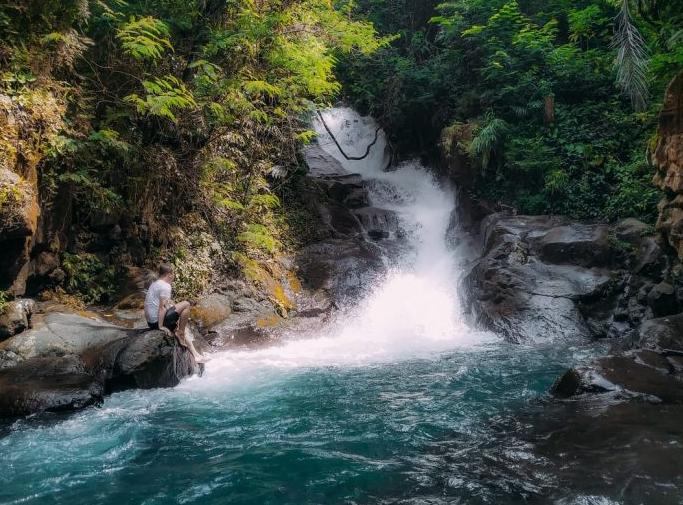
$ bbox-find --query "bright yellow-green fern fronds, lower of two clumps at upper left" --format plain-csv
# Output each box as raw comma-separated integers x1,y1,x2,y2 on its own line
125,75,197,122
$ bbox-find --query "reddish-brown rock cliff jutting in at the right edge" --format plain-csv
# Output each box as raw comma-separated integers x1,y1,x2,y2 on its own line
651,73,683,259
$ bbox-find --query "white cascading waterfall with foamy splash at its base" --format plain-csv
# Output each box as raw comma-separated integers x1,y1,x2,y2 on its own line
186,108,486,388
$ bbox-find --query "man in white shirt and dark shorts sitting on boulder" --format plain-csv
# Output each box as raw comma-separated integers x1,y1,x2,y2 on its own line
145,263,204,363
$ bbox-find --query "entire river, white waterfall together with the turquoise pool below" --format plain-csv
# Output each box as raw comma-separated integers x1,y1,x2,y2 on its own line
0,109,681,505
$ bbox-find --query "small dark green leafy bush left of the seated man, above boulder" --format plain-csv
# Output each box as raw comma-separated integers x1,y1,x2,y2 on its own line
62,252,116,304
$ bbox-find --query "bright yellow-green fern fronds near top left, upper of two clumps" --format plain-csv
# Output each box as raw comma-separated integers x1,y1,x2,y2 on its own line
116,16,173,61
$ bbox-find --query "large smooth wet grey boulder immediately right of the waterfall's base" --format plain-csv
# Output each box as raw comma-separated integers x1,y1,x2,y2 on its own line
464,214,618,342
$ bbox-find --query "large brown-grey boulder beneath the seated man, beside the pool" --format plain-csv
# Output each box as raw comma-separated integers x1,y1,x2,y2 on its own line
0,313,201,417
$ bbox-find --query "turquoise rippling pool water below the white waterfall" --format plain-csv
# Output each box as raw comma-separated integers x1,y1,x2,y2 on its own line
0,344,600,504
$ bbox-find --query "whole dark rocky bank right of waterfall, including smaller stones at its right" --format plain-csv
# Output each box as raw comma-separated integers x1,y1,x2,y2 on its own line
464,214,672,342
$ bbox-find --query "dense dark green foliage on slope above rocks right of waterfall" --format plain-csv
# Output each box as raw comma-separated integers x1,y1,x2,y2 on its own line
343,0,683,221
